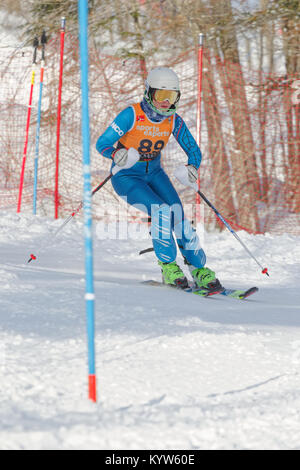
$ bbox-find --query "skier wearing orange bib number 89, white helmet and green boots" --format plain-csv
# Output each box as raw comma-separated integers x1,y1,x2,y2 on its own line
96,67,222,293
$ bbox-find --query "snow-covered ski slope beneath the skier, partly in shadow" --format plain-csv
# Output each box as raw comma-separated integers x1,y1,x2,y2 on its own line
0,213,300,449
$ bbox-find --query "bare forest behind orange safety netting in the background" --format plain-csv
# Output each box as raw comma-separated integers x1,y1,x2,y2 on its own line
0,0,300,233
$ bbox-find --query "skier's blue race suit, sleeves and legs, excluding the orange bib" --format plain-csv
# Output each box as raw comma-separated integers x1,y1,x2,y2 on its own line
96,99,206,268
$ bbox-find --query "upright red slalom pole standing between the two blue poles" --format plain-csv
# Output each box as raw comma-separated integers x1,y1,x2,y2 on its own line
54,17,66,219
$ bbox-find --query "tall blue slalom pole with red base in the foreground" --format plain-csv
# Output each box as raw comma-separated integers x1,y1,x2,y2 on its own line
78,0,97,402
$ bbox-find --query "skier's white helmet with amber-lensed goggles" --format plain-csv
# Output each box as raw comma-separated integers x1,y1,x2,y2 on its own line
144,67,180,116
